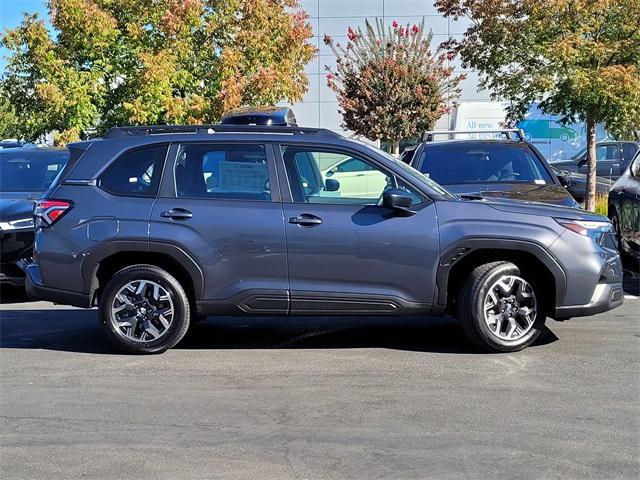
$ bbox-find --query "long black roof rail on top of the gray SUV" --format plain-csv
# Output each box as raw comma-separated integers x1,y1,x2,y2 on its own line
103,123,342,138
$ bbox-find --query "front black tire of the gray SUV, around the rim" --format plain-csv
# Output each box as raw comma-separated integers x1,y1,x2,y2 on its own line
457,262,546,352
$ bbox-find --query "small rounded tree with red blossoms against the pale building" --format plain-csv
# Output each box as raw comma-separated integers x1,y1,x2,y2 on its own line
324,19,463,154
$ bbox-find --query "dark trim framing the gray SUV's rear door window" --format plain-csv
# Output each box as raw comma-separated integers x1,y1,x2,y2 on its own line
159,140,281,203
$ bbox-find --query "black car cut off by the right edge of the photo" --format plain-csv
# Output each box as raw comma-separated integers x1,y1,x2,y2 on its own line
609,153,640,269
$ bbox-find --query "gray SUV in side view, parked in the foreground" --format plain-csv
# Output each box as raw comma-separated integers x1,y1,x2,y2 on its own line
27,125,623,353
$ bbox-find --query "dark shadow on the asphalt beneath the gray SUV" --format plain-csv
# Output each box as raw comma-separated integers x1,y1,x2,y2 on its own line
0,309,557,354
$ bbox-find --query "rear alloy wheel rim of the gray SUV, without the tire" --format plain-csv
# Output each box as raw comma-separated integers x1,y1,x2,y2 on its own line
111,280,174,342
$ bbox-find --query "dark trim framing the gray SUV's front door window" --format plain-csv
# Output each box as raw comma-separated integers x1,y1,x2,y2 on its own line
273,142,433,208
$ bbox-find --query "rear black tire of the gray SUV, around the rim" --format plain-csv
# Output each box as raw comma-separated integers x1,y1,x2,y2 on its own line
98,265,191,354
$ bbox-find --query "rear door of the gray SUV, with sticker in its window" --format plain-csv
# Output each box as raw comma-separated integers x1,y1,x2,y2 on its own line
150,142,288,314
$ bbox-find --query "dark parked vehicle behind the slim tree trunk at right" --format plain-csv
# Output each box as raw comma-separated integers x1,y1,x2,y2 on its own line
551,141,640,180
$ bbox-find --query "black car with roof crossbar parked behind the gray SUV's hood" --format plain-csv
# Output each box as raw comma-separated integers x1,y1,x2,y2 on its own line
403,130,579,208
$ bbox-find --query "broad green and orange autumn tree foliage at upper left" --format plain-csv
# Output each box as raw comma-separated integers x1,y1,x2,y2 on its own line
1,0,315,139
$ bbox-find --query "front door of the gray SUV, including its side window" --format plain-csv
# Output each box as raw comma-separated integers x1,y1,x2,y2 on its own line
280,146,438,314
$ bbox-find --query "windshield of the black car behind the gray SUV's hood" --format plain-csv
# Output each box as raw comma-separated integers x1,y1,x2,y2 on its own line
420,142,553,185
